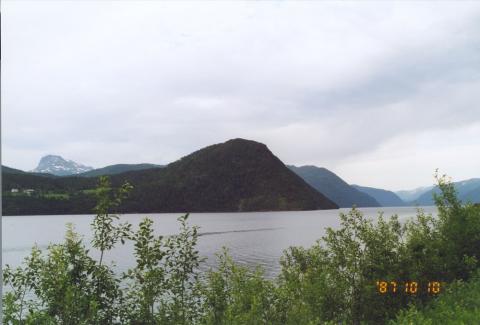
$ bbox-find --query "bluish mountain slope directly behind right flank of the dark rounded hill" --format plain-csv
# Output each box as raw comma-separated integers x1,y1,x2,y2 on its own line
288,166,380,208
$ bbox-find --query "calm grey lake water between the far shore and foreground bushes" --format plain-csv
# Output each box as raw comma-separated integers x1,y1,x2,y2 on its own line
2,207,437,276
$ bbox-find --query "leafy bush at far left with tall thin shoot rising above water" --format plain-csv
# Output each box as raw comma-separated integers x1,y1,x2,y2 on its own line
4,177,131,324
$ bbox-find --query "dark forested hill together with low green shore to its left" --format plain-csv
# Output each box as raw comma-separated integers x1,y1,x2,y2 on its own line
3,139,338,215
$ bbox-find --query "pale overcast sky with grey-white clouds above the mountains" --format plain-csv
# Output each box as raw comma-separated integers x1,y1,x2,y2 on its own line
2,0,480,190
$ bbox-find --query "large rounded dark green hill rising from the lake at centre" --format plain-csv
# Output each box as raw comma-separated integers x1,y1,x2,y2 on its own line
112,139,337,212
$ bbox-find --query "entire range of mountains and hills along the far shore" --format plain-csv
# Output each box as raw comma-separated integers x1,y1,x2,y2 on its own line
2,139,480,214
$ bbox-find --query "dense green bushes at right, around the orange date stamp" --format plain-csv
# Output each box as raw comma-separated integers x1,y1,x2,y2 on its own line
279,172,480,324
